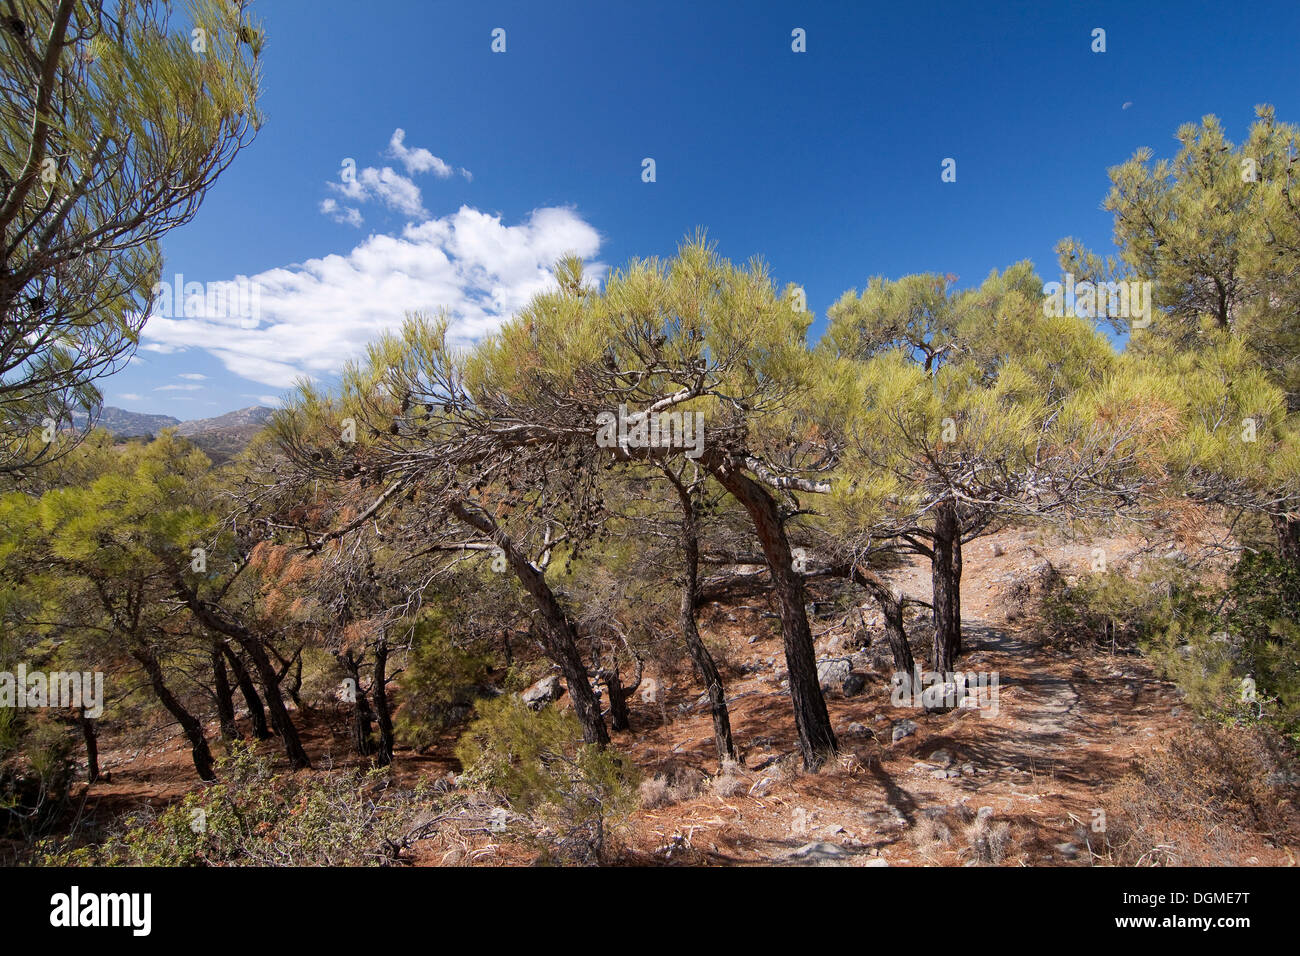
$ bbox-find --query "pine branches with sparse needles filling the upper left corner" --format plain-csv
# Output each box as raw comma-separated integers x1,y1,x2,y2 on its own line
0,0,263,473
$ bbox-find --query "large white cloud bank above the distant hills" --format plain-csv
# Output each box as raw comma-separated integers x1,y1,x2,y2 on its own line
143,206,605,398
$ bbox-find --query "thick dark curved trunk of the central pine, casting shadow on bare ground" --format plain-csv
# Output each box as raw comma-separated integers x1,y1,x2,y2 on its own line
710,463,839,770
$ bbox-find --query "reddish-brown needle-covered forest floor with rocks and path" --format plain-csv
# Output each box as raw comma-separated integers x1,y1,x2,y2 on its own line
53,522,1300,866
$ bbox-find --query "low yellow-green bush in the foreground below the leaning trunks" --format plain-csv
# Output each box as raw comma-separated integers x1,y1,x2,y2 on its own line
456,695,641,861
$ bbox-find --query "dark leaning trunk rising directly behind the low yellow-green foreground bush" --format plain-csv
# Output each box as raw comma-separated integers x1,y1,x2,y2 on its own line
450,501,610,747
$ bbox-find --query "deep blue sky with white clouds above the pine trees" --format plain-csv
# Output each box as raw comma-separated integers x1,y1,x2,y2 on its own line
103,0,1300,419
